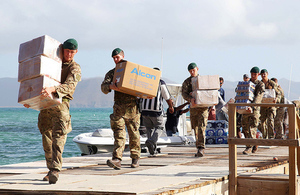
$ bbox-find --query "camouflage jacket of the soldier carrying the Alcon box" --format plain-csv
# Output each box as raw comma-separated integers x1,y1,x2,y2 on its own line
101,68,137,105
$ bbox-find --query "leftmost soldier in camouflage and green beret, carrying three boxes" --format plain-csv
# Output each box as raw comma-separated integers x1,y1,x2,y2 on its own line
24,39,81,184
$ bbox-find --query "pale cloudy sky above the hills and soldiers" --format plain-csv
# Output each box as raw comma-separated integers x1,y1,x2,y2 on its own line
0,0,300,83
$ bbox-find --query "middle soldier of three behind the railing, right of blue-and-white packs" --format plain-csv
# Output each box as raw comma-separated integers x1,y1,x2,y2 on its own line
259,69,280,139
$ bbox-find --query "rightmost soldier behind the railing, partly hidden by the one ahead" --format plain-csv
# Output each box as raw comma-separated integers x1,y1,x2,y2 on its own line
271,78,286,139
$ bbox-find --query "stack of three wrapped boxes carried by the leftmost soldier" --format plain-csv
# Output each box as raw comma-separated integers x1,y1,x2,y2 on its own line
18,35,62,110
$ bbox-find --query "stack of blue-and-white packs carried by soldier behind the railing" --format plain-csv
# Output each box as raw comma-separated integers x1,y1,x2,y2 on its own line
235,81,255,114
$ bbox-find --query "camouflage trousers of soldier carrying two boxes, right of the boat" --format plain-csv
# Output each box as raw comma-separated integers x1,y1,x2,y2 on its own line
190,107,208,148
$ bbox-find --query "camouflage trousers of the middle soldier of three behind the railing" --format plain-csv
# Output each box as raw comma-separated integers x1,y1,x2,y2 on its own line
258,107,276,139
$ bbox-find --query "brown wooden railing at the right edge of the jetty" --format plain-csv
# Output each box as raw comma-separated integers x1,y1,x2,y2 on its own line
228,103,300,195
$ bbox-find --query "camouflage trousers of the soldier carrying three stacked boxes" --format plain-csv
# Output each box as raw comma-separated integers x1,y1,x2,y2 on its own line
38,102,72,171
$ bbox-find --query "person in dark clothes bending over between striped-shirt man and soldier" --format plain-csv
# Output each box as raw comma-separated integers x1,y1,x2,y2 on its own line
165,102,190,136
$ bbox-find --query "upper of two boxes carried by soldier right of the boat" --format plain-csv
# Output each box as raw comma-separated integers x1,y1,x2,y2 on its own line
192,75,220,91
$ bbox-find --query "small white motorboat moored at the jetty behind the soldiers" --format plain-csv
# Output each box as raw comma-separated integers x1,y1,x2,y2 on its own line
73,84,196,155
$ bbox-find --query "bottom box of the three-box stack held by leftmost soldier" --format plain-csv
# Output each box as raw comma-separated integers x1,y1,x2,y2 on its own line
18,76,62,110
